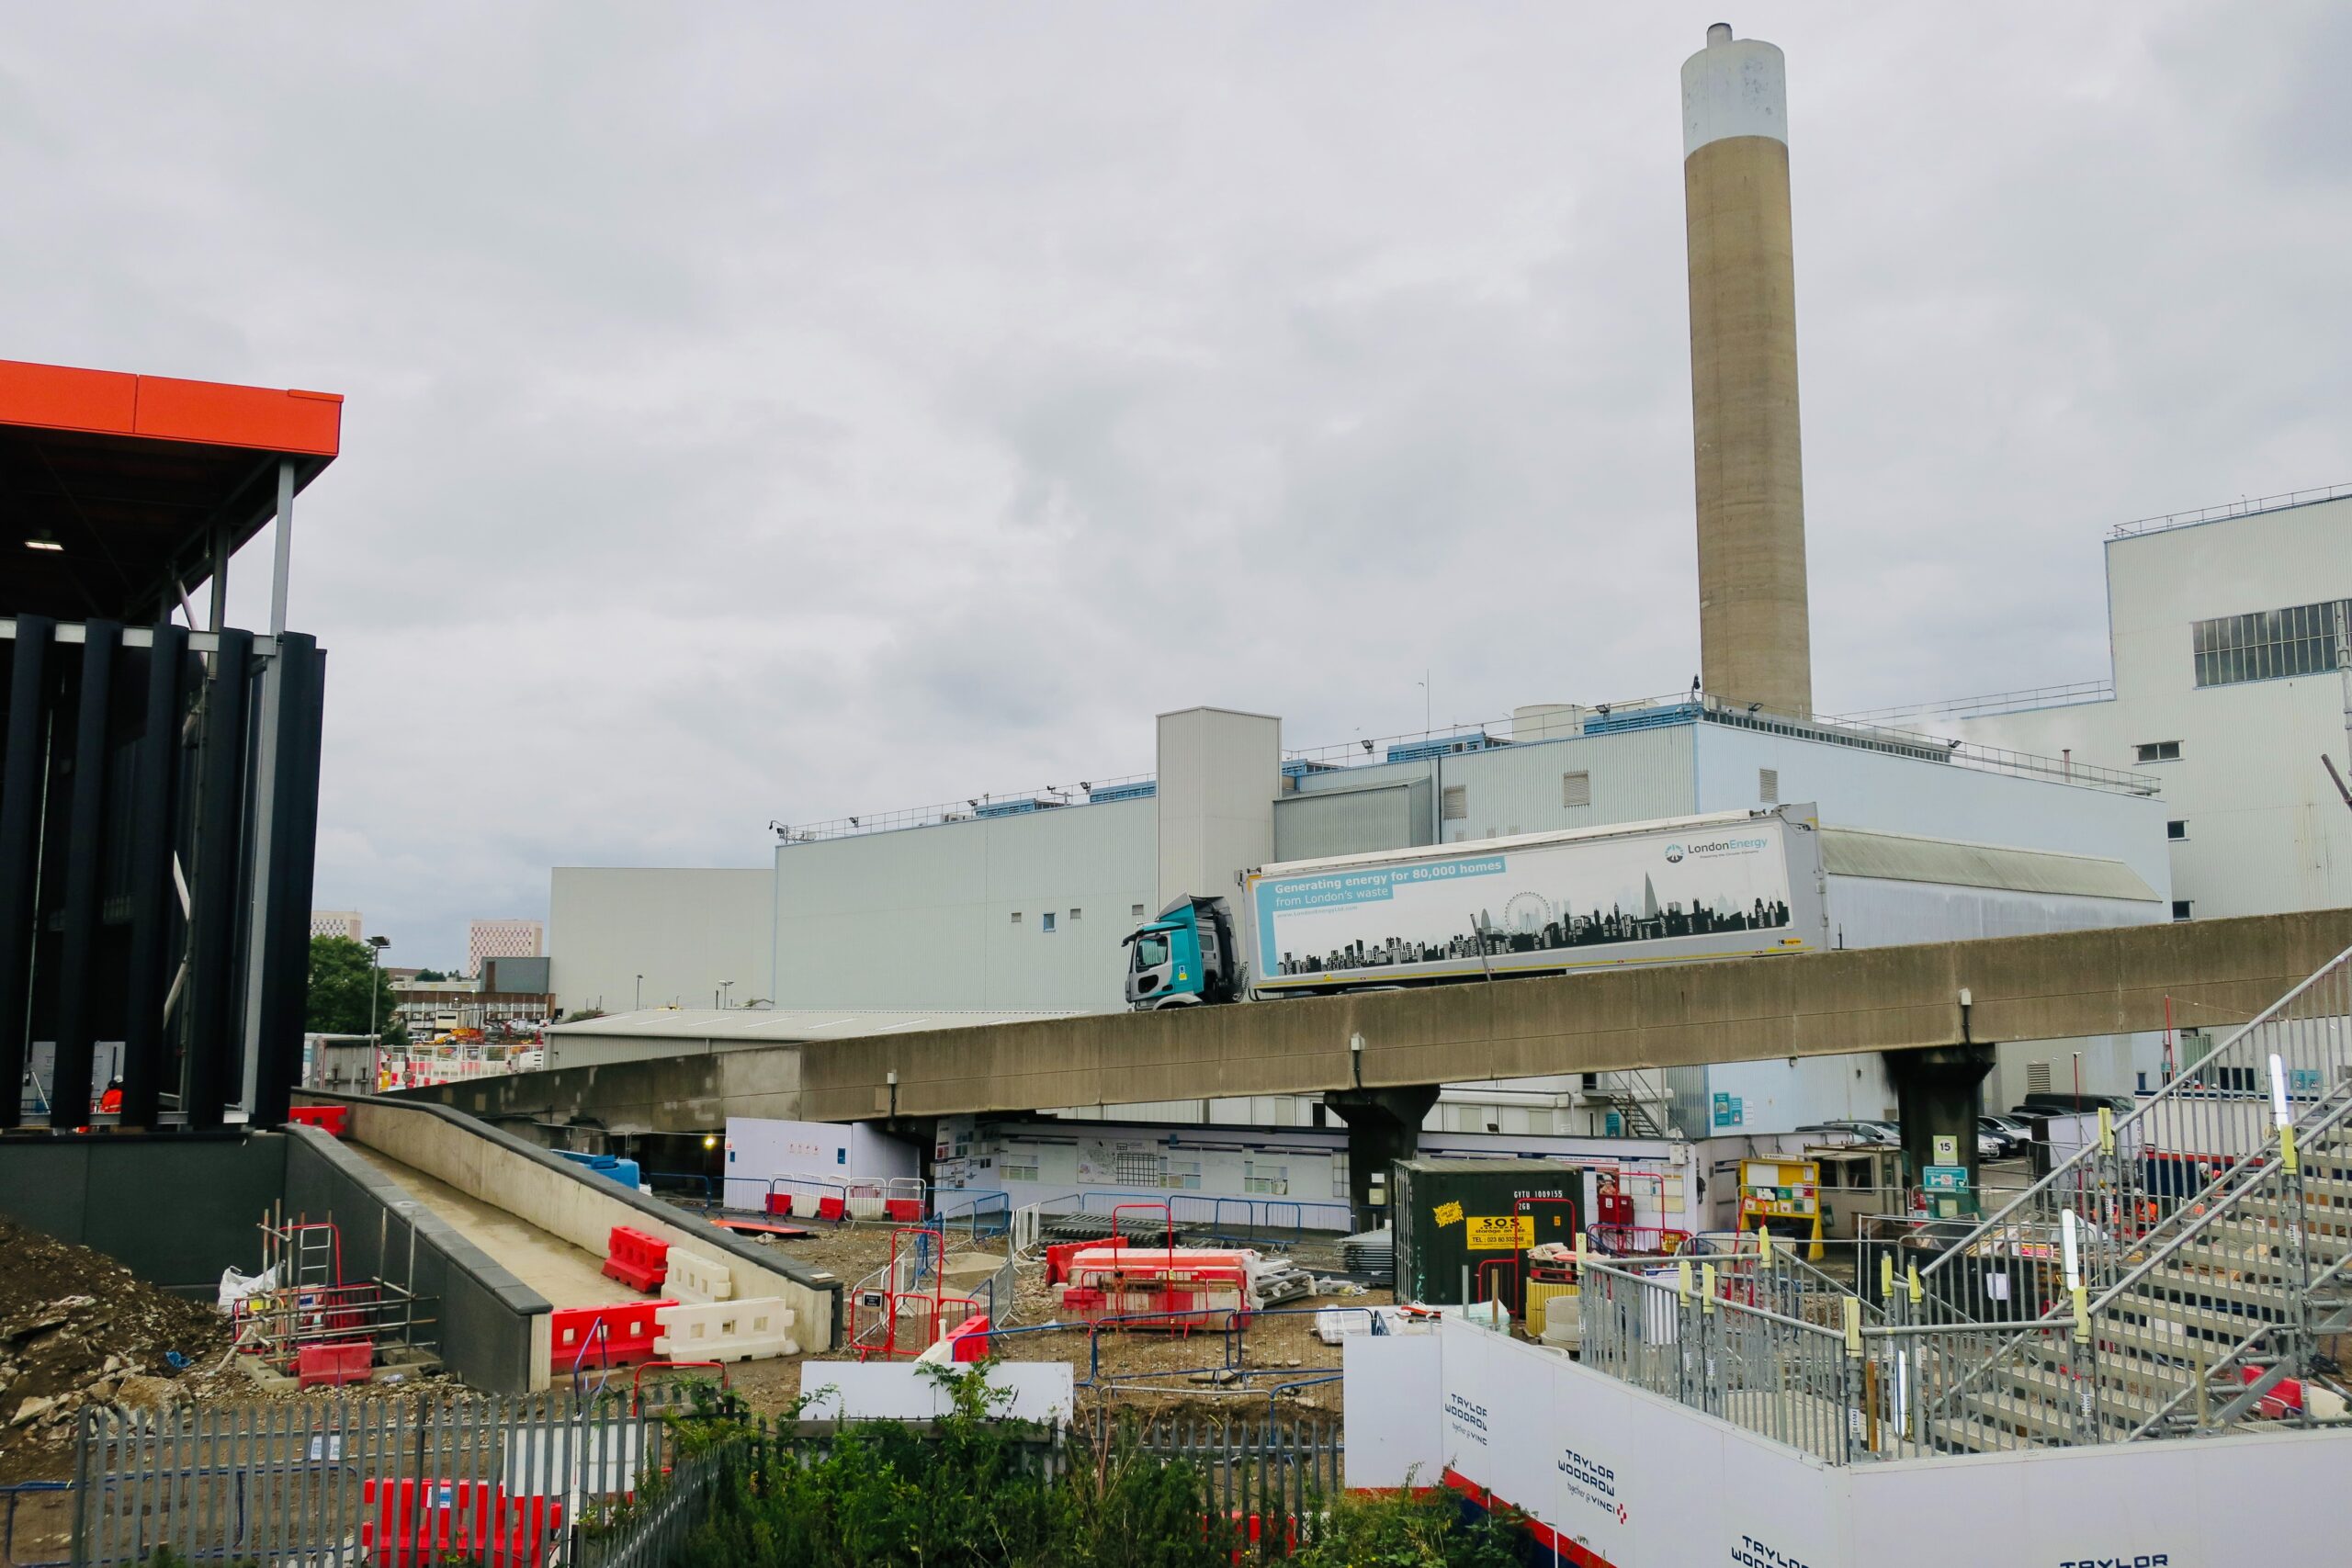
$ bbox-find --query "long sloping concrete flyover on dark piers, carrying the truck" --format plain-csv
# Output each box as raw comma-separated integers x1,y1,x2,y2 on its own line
412,909,2352,1203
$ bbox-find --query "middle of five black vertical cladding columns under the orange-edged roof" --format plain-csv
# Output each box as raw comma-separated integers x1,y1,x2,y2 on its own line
122,621,188,1126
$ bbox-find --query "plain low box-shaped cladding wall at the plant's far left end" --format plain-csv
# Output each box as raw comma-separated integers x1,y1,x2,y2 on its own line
548,865,774,1013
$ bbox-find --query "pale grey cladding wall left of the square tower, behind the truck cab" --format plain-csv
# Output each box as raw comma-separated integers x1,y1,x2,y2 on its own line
776,799,1159,1010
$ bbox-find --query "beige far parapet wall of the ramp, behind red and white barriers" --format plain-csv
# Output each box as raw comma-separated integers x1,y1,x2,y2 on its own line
301,1093,842,1352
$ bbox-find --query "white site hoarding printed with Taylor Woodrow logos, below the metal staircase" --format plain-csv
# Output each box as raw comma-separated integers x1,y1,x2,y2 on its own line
1345,1321,2352,1568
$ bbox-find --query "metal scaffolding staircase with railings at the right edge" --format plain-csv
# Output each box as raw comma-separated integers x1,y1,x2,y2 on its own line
1884,952,2352,1453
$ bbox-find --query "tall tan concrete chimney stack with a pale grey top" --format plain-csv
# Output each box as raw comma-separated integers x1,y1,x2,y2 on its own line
1681,21,1814,717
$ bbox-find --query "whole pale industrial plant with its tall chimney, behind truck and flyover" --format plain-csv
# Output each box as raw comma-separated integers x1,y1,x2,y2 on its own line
550,17,2352,1194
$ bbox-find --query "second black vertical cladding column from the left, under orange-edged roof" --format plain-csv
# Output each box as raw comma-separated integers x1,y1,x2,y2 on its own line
50,621,122,1128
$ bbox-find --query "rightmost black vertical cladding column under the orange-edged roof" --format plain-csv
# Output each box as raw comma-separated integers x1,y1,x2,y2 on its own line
252,632,327,1126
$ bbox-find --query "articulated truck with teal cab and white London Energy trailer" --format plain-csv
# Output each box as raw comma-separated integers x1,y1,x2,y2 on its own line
1126,804,1827,1009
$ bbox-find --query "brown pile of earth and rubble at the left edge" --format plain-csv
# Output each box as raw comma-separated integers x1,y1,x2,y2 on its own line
0,1220,228,1470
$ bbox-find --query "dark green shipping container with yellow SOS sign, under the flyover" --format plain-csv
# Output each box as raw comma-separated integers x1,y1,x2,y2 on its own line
1393,1159,1585,1309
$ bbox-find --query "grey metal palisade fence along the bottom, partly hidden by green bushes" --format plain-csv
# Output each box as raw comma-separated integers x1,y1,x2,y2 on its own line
71,1384,1343,1568
